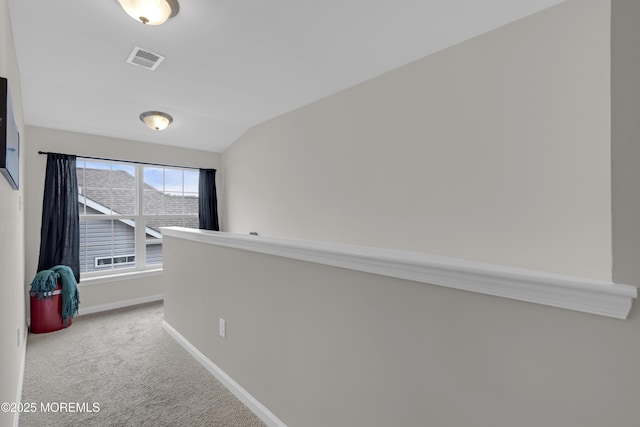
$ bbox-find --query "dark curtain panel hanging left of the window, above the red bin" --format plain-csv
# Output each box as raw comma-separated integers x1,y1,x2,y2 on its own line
38,153,80,283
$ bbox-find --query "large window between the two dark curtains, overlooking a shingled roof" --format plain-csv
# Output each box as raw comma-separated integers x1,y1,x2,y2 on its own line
76,158,199,277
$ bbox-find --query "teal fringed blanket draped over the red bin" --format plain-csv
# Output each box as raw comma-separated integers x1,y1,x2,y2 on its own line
30,265,80,325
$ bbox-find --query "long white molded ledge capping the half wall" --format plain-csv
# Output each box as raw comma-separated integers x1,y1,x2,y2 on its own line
161,227,638,319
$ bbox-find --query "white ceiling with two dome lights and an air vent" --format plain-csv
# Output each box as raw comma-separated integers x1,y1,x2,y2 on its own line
9,0,563,152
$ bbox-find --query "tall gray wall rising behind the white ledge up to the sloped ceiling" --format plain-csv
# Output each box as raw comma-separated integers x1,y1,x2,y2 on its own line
223,0,612,280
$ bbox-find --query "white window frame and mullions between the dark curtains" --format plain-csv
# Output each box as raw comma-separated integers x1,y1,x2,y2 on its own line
77,157,197,279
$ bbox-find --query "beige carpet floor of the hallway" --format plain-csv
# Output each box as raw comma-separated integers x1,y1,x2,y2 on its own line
20,303,264,427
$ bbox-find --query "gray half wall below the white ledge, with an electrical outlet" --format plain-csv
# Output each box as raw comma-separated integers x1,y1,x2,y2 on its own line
164,237,640,427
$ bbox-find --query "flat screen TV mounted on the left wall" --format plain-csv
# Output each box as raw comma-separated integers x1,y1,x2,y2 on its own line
0,77,20,190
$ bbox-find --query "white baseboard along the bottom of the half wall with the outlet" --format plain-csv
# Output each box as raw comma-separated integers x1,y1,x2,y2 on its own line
162,320,287,427
